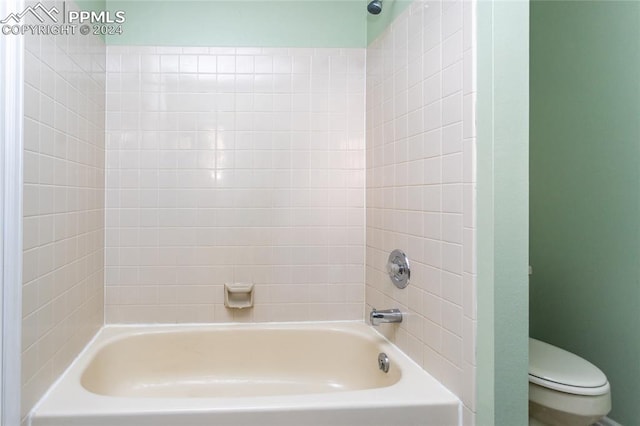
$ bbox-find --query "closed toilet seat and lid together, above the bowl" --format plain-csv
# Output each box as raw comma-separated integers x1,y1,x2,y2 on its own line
529,338,610,396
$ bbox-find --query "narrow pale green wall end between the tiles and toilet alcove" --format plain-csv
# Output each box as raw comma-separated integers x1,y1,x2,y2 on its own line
476,0,529,426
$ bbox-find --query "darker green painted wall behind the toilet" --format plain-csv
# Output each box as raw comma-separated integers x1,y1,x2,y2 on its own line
530,1,640,425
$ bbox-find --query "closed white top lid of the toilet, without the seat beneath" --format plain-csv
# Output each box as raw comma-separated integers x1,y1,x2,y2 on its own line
529,338,607,388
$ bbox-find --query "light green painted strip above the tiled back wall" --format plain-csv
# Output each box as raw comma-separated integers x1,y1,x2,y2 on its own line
107,0,368,47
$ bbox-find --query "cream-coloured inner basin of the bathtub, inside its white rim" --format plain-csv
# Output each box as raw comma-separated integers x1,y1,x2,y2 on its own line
80,327,401,398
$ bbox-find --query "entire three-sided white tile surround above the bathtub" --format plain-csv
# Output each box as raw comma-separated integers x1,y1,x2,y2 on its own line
22,1,476,424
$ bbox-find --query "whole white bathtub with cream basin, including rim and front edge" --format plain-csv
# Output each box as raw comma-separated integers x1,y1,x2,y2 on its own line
30,322,460,426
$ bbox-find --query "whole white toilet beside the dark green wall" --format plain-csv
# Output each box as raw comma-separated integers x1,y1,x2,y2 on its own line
529,338,611,426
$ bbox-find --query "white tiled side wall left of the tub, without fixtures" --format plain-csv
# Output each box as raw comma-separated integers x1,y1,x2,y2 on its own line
22,2,105,417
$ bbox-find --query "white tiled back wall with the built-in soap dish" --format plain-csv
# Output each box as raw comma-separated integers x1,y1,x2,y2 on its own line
106,46,365,322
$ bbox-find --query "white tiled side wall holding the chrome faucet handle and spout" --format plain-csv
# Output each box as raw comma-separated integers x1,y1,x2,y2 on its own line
366,0,476,424
